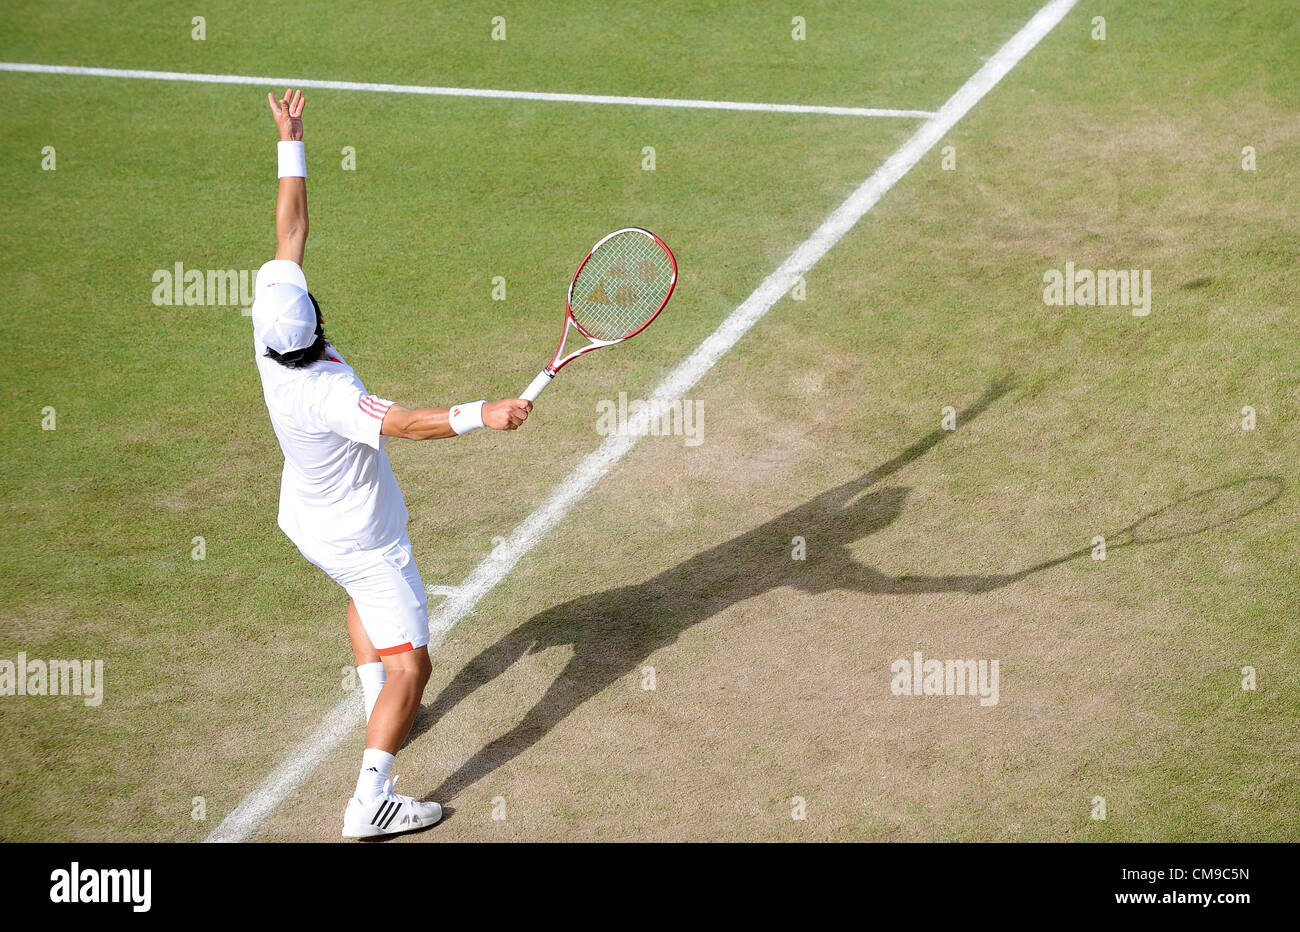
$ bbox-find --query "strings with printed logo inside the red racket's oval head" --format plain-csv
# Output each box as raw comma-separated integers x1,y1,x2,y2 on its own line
569,231,672,339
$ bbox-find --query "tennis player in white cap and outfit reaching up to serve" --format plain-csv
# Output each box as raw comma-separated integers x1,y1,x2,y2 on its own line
252,90,533,838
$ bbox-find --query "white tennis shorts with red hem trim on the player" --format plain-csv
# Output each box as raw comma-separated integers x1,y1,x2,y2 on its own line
299,534,429,656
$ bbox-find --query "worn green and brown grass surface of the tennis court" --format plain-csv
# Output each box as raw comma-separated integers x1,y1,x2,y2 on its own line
0,0,1300,841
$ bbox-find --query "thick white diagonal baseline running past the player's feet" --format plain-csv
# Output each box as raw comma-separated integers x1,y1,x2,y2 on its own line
207,0,1076,841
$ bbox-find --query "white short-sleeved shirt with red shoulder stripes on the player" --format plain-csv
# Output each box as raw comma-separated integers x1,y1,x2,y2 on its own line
254,265,408,563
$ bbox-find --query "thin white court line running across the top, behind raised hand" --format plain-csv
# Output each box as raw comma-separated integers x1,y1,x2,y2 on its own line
0,61,935,120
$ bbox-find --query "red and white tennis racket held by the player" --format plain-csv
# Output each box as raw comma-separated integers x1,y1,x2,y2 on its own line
520,226,677,402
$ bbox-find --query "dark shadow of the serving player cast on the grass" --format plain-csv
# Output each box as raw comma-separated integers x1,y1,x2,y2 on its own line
410,383,1281,801
